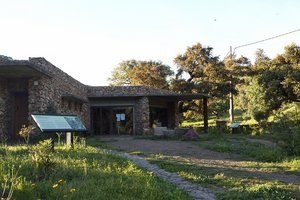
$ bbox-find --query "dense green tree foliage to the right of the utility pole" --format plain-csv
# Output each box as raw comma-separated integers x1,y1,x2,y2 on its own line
240,44,300,117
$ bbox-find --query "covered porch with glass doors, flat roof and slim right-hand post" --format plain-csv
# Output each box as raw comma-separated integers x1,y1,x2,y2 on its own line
89,93,209,135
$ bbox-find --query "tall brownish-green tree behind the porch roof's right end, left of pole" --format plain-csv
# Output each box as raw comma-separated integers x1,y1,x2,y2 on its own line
172,43,232,118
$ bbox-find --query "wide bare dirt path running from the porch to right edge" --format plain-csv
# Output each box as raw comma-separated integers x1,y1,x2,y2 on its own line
101,136,300,185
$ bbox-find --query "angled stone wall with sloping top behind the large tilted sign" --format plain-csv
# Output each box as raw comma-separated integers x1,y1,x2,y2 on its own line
28,58,90,129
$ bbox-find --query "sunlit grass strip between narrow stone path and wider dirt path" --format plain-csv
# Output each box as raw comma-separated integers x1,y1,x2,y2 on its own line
148,156,300,199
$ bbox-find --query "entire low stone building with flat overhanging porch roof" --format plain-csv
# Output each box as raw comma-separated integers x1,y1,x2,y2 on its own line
0,56,208,138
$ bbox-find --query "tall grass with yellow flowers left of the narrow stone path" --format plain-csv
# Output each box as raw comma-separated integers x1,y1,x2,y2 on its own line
0,141,191,200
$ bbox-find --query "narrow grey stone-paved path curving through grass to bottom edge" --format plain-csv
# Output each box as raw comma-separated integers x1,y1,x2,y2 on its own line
102,150,216,200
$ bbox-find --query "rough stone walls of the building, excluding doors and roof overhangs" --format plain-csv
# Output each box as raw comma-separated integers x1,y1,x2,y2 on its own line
0,57,184,138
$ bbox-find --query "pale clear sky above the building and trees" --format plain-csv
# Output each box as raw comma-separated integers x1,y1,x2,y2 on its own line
0,0,300,86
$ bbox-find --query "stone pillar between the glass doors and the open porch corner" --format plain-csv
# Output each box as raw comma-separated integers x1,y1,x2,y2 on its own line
135,97,150,135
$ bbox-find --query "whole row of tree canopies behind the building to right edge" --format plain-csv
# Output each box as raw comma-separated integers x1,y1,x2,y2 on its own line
109,43,300,122
